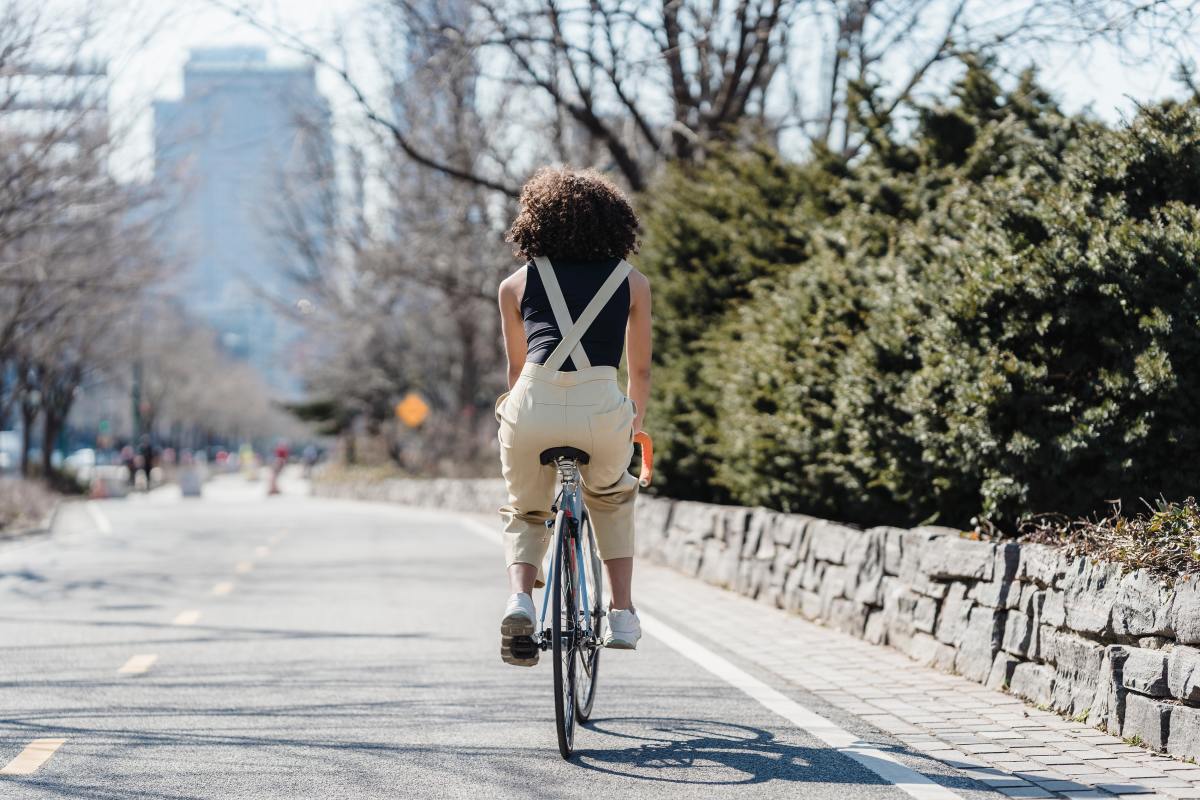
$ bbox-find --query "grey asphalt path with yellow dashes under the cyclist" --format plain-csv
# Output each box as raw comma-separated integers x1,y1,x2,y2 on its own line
0,479,997,800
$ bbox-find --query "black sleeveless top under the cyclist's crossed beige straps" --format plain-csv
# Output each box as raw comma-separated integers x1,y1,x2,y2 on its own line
521,258,629,372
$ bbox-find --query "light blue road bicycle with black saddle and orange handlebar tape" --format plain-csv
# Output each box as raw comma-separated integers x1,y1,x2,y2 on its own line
532,433,654,758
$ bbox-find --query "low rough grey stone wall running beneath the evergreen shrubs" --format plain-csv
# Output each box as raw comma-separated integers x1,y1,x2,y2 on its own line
314,480,1200,758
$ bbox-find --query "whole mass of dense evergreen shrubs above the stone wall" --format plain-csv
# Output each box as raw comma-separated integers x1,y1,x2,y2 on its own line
647,64,1200,529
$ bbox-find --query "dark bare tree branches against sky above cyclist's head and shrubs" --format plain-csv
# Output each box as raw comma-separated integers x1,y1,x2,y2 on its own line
220,0,1200,197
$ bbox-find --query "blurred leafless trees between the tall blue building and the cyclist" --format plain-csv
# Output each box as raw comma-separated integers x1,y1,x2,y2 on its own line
277,6,514,464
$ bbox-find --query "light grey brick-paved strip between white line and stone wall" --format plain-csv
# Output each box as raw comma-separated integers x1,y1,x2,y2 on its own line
636,561,1200,799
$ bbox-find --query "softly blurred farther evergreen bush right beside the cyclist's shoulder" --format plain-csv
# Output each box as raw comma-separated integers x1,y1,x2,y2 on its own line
638,141,822,498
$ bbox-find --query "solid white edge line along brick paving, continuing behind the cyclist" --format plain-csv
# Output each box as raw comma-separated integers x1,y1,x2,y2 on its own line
460,517,962,800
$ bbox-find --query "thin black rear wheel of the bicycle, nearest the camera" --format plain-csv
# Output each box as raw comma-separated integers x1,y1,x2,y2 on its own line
551,511,580,758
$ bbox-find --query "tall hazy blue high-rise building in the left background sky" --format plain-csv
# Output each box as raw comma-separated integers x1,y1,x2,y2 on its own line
155,47,331,399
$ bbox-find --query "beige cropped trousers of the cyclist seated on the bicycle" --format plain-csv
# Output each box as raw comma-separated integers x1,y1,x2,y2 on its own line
496,363,637,585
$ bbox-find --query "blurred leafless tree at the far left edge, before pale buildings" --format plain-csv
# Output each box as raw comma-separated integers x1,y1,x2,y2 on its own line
0,0,166,473
